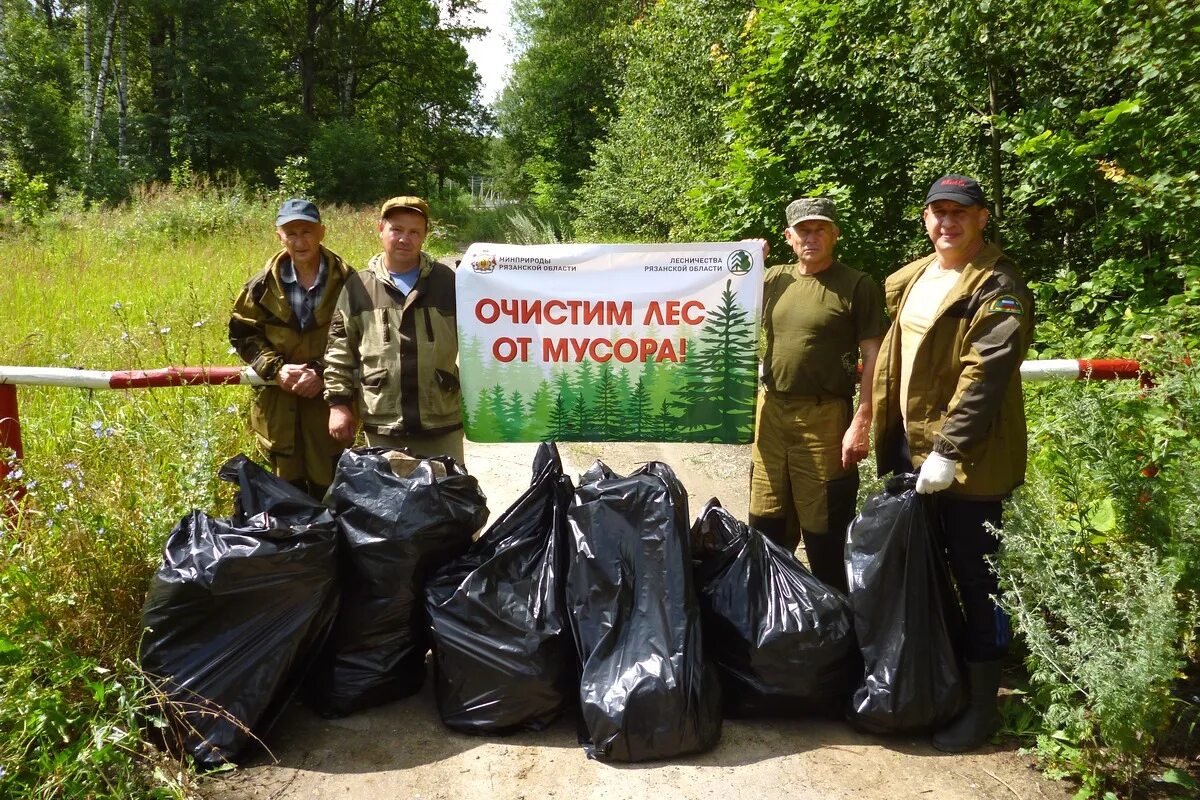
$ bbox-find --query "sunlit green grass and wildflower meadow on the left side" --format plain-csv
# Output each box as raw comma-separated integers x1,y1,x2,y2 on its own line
0,188,468,799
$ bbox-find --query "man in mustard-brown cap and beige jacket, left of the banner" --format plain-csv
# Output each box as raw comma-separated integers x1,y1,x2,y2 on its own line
325,196,463,464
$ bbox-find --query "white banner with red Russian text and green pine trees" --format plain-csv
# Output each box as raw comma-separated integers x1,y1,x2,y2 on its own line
457,242,763,443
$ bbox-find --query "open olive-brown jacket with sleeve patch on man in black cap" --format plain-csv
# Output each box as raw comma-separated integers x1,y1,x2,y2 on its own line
872,243,1033,499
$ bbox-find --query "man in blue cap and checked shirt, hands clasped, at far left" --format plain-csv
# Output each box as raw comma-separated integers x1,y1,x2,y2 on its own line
229,198,354,498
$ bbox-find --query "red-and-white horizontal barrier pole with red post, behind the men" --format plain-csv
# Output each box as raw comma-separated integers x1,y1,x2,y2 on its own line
0,359,1147,513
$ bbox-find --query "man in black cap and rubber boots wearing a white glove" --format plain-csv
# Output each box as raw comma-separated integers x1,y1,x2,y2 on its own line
874,175,1033,752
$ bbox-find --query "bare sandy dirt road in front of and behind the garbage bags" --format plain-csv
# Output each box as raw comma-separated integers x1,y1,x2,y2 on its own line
202,443,1070,800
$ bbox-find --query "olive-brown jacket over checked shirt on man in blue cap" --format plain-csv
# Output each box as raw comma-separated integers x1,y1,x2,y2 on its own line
229,246,354,455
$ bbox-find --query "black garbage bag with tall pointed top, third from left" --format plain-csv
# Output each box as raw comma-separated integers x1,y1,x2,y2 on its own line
425,441,578,734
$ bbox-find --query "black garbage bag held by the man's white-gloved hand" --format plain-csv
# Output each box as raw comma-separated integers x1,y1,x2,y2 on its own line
846,475,966,733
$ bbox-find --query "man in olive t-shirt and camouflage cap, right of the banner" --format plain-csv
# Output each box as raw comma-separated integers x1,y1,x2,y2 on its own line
750,198,887,591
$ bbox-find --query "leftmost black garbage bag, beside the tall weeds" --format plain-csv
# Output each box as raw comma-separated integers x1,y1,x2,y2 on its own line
139,456,337,769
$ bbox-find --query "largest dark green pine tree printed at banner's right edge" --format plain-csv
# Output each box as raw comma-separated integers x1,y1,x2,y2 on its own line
671,281,758,441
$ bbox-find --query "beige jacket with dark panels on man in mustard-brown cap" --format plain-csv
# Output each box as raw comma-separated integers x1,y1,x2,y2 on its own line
325,253,462,435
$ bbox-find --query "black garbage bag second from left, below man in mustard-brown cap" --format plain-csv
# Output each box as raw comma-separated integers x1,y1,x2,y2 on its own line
308,447,487,716
